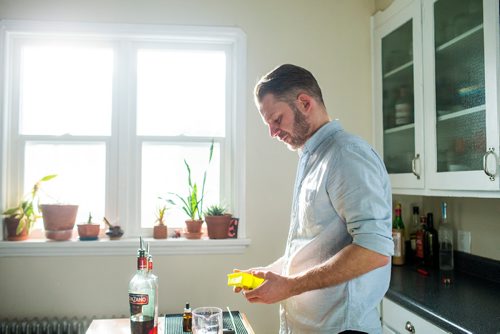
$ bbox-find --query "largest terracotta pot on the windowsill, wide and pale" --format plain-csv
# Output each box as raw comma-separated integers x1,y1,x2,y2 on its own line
41,204,78,241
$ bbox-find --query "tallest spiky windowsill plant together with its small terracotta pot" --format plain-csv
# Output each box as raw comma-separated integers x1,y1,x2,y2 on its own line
173,140,214,239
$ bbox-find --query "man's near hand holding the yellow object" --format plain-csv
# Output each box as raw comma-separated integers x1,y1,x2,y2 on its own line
241,270,293,304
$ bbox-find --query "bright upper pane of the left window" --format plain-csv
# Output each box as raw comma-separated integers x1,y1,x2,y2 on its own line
20,45,113,135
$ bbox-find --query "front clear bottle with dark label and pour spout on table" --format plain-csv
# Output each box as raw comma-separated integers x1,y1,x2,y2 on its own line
128,238,155,334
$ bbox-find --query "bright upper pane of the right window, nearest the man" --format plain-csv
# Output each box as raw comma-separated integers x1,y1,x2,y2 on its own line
137,49,226,137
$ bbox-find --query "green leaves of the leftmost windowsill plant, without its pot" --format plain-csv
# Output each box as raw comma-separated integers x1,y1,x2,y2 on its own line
2,174,57,234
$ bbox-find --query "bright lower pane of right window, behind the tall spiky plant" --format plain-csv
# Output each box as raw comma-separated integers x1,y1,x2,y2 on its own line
141,143,220,227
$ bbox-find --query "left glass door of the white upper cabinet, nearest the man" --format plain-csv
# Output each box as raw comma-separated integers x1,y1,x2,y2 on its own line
374,1,424,193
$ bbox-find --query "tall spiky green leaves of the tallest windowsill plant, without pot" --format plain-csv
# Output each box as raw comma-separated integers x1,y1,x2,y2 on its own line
173,140,214,220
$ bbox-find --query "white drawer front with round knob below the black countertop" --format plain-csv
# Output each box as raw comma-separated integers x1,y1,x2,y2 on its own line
382,298,448,334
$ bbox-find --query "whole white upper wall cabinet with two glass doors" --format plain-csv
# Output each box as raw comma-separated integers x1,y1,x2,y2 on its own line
372,0,500,197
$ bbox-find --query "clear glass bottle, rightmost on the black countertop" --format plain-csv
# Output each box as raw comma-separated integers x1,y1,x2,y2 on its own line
439,202,453,283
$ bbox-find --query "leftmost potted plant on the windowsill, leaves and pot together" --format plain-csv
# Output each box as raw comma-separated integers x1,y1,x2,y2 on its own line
2,175,57,241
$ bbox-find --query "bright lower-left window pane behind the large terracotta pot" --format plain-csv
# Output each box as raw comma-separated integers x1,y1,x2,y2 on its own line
24,143,106,223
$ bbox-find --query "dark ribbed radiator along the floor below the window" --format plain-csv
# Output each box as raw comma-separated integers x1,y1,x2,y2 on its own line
0,317,92,334
